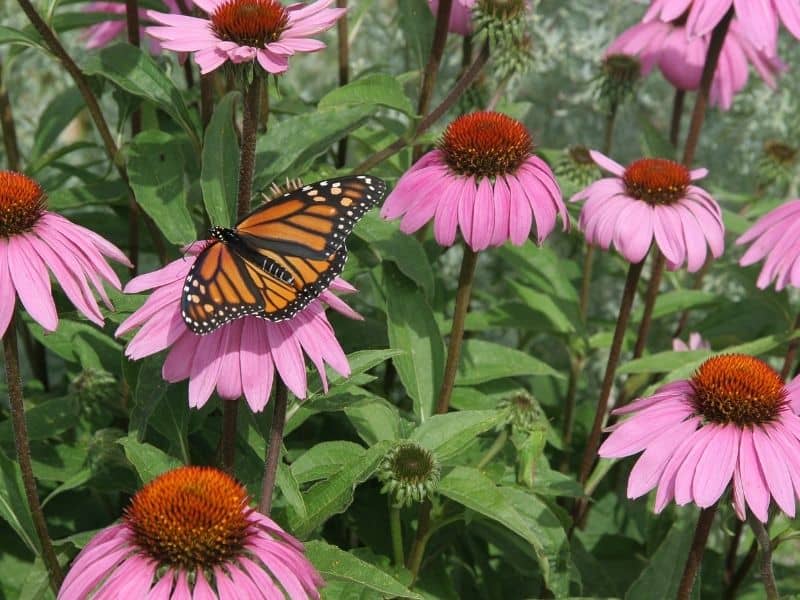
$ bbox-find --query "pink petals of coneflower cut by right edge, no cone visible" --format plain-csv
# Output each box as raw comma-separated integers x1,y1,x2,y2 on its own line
736,199,800,291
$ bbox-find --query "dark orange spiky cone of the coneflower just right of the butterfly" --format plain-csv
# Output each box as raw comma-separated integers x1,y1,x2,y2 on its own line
439,112,532,177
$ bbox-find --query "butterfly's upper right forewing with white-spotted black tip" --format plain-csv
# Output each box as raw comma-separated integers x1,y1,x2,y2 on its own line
235,175,386,260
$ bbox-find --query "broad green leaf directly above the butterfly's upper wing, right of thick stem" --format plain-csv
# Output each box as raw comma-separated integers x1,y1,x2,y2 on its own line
254,106,376,190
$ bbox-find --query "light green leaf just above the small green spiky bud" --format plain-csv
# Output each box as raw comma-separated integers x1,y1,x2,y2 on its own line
411,410,503,461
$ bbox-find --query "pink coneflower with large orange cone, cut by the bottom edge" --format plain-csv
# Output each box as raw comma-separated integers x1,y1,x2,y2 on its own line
58,467,323,600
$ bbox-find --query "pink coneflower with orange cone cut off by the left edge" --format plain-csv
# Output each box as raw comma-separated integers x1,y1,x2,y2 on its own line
0,171,130,336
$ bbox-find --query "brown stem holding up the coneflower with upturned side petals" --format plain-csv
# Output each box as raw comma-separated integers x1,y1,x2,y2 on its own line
578,260,644,488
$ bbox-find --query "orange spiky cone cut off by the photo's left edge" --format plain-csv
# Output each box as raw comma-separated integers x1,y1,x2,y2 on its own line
0,171,47,237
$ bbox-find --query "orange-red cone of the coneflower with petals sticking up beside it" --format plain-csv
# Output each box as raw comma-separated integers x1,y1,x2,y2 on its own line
622,158,692,205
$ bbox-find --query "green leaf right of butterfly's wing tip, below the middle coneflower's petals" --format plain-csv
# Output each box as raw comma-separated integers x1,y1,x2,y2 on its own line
354,216,435,298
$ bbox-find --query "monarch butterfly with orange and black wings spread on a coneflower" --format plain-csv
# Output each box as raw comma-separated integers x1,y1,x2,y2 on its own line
181,175,386,335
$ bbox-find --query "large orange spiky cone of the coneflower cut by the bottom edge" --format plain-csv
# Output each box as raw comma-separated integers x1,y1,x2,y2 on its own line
124,467,250,571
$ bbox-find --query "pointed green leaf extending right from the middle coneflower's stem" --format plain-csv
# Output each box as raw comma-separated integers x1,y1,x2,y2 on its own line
456,339,564,385
